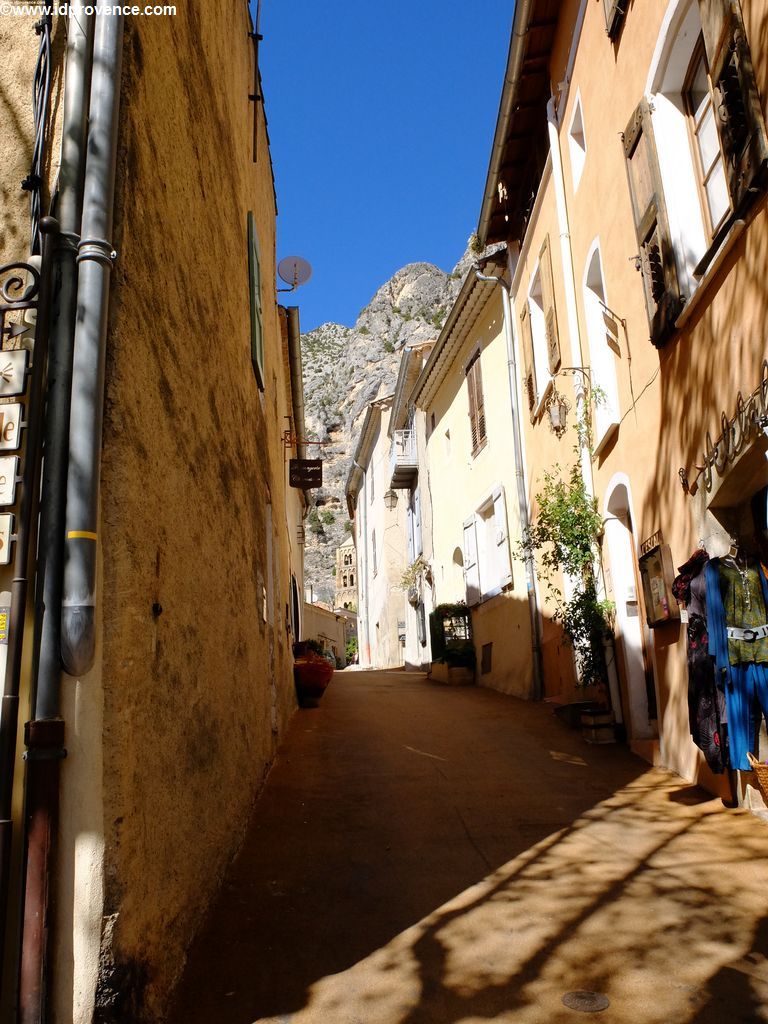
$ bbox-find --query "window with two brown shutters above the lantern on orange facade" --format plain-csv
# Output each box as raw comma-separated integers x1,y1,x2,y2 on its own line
520,236,560,422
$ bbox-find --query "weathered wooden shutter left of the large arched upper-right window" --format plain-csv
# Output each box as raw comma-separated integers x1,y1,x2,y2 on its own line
624,99,683,348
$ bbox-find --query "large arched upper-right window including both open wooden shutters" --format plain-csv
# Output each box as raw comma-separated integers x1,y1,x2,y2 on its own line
624,0,768,347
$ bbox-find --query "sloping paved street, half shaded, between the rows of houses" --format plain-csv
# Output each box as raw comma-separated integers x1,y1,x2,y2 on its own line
170,672,768,1024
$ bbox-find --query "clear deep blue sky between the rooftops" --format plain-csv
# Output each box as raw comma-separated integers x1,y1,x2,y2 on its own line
260,0,514,331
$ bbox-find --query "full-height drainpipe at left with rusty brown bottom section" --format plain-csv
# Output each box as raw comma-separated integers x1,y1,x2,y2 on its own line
19,5,93,1022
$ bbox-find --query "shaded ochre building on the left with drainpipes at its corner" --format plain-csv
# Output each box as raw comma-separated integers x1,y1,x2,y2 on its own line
0,0,305,1024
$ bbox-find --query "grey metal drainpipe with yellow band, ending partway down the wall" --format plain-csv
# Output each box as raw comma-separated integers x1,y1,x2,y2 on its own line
61,10,123,676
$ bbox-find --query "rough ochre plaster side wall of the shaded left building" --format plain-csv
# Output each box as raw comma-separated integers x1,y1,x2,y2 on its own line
45,6,302,1021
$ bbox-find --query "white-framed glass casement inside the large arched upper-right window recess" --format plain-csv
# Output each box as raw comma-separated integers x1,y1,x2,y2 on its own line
683,37,730,241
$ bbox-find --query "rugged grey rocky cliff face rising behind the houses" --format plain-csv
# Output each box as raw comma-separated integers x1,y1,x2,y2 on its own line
301,253,471,601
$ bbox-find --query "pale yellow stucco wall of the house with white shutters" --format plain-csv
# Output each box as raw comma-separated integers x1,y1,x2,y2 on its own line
425,286,531,696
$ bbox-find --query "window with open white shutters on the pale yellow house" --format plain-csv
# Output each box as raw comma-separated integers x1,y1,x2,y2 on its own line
464,487,513,604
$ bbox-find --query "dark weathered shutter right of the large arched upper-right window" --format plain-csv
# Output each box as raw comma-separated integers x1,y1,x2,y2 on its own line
699,0,768,210
